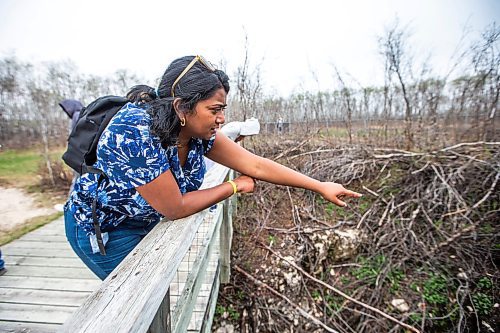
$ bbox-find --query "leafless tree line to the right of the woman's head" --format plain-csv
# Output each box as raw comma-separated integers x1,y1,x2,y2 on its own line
231,22,500,149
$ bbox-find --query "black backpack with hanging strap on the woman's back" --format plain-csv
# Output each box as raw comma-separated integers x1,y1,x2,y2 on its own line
62,96,128,255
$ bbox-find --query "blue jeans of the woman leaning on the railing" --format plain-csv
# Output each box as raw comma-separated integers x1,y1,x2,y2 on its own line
64,205,158,280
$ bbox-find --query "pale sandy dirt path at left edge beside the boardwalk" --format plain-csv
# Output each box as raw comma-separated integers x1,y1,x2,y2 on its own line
0,187,56,234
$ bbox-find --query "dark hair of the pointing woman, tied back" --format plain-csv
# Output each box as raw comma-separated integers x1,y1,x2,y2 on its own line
127,56,229,148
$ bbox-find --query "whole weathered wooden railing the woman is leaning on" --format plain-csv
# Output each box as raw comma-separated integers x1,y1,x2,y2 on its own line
60,164,234,333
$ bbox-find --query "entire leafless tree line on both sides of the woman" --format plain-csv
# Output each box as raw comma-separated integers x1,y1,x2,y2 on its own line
0,23,500,149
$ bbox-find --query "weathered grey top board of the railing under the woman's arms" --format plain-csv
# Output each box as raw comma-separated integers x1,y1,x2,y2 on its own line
60,164,230,333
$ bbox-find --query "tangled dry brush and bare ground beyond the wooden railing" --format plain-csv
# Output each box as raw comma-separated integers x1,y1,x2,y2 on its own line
214,139,500,332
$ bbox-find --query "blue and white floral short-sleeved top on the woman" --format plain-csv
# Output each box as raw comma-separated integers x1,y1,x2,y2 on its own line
68,103,215,235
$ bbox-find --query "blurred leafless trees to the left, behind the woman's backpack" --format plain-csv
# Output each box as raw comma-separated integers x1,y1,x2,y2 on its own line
0,56,141,148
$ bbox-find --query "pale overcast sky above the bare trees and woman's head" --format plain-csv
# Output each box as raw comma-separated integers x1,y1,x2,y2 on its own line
0,0,500,95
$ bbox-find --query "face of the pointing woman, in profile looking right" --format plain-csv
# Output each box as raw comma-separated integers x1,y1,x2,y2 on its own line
180,88,226,140
